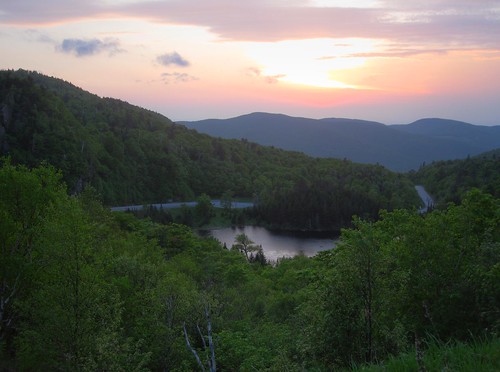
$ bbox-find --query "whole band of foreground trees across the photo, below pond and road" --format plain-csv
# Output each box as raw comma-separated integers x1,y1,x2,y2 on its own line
0,160,500,371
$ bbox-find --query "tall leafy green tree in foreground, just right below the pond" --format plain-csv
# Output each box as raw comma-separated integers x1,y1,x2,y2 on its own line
301,219,383,369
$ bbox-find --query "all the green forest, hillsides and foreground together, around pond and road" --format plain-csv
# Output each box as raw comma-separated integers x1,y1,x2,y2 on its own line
0,71,500,371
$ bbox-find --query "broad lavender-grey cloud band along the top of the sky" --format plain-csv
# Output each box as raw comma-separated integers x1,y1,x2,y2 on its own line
0,0,500,49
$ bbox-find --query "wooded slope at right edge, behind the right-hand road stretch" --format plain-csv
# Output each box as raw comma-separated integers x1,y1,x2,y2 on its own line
410,149,500,205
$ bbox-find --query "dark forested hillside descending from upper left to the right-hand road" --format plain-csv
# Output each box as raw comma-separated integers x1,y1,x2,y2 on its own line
0,70,419,229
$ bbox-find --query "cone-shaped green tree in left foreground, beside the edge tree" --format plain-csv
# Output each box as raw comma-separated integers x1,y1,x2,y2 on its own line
17,197,149,370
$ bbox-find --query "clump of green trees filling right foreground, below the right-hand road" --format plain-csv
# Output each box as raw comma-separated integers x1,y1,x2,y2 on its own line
301,190,500,368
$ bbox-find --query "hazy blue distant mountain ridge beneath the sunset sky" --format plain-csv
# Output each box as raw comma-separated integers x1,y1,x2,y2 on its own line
180,112,500,171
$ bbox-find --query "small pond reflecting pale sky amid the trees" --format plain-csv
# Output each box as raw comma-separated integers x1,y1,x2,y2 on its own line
199,226,338,261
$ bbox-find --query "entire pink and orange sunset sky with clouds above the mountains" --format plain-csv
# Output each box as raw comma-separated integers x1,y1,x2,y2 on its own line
0,0,500,125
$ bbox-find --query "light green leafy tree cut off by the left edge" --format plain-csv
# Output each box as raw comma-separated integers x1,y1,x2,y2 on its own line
0,159,66,341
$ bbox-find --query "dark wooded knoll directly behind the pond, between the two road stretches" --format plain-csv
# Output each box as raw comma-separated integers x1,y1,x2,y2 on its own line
255,159,420,231
